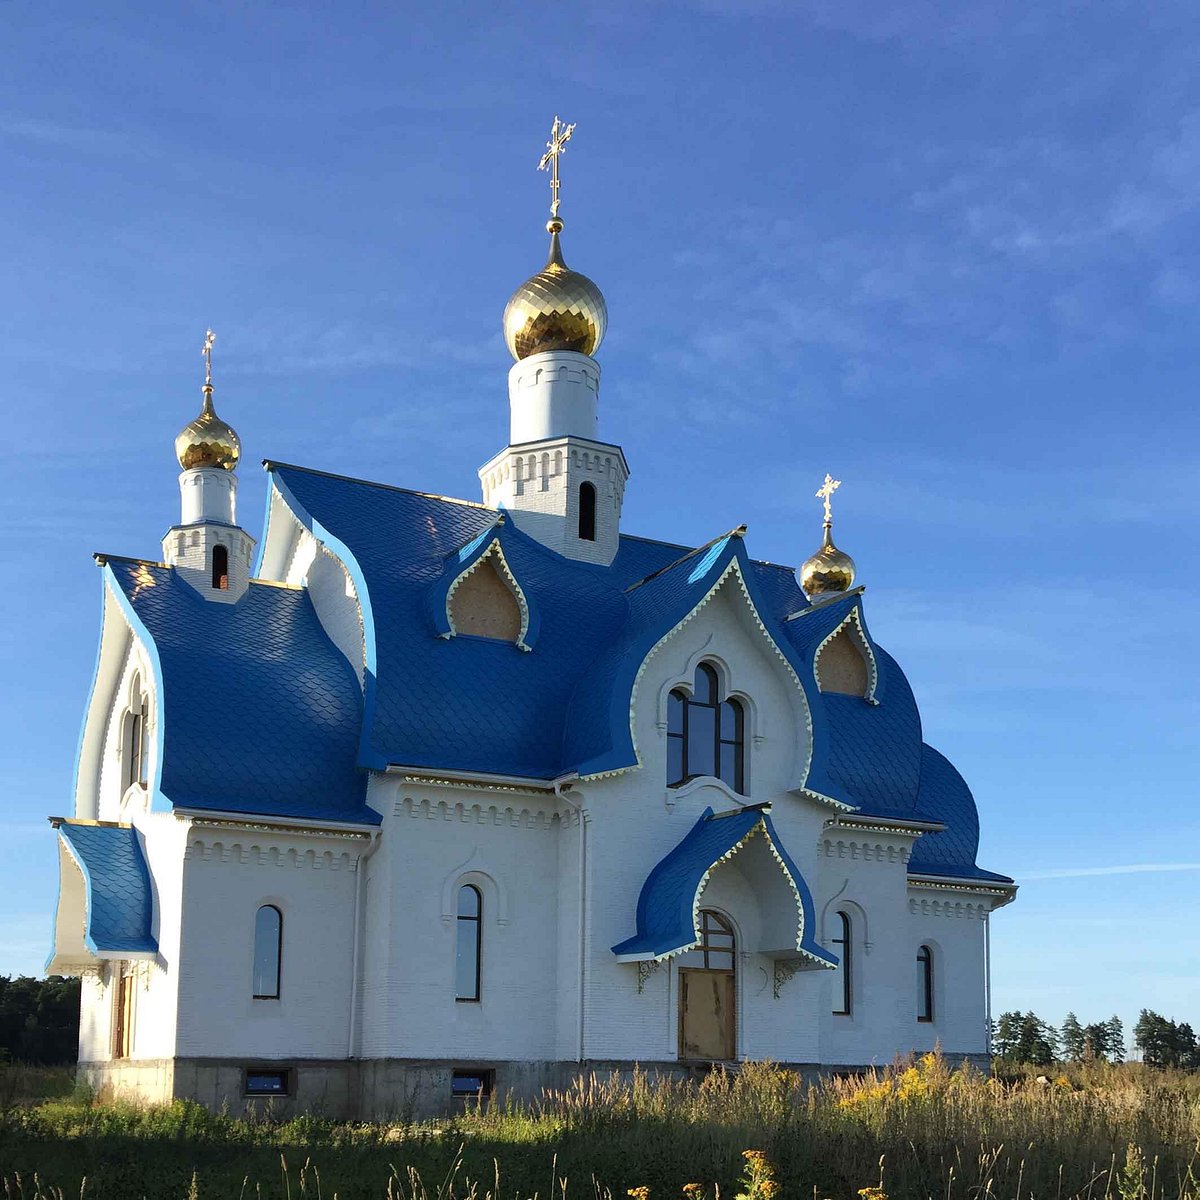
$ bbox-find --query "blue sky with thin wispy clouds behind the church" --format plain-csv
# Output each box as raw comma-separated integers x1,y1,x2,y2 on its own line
0,0,1200,1041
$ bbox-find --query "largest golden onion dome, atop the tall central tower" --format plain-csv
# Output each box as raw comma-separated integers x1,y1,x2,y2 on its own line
504,217,608,361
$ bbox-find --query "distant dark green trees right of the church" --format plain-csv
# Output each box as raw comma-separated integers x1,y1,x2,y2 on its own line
992,1008,1200,1070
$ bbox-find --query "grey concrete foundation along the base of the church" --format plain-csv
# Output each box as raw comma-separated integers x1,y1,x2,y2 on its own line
78,1055,991,1121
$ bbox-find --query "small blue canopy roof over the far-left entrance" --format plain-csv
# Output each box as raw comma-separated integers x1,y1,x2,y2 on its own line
59,821,158,954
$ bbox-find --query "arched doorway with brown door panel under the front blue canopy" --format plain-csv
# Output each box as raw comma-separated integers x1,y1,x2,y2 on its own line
678,908,738,1062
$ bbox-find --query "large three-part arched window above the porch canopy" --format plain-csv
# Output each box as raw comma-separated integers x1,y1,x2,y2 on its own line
667,662,745,792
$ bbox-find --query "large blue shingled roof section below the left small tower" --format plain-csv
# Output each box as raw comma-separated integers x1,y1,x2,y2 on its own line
106,559,379,824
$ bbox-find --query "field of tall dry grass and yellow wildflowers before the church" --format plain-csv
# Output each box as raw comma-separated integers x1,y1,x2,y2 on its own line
0,1056,1200,1200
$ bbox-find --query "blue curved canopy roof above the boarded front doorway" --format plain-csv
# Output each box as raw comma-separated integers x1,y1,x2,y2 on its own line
612,808,838,966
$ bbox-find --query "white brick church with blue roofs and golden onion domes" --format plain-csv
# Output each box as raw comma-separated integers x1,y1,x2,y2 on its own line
47,119,1016,1118
